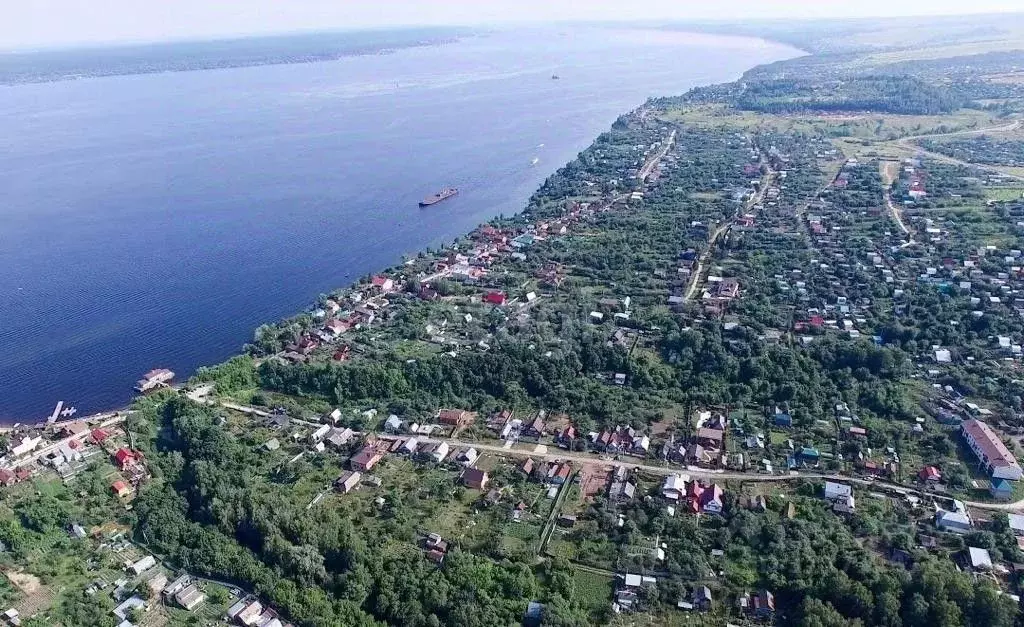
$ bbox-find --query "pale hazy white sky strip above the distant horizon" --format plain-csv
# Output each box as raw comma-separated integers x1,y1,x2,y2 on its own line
6,0,1022,49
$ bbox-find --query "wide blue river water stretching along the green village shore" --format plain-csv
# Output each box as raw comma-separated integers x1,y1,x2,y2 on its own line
0,29,796,421
